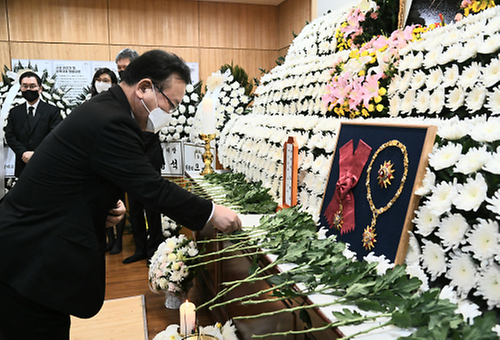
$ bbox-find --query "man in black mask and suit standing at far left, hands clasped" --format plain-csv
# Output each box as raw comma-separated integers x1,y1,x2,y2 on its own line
5,71,62,177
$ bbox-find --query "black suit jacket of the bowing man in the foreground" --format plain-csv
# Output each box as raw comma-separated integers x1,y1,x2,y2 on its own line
0,86,212,317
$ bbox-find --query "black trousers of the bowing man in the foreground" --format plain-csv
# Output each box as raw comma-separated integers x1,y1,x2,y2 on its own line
0,282,71,340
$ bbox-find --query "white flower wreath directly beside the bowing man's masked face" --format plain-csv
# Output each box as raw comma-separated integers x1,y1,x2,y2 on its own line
159,82,202,142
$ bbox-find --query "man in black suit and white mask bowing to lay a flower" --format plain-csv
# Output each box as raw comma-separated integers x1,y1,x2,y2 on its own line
0,50,241,340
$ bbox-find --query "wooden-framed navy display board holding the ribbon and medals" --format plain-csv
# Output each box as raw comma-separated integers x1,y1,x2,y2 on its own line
320,122,437,264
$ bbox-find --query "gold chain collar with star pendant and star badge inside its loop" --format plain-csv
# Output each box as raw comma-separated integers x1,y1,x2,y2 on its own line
362,139,408,250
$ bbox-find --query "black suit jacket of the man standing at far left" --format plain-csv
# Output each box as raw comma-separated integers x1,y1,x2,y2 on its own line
5,100,62,177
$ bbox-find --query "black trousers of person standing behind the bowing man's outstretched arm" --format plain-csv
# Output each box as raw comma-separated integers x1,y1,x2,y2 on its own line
128,195,163,258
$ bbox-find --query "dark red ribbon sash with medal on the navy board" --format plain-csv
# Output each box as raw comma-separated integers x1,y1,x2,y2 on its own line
324,139,372,234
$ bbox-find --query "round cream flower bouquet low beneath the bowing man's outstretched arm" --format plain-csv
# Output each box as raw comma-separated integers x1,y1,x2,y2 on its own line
149,234,198,295
